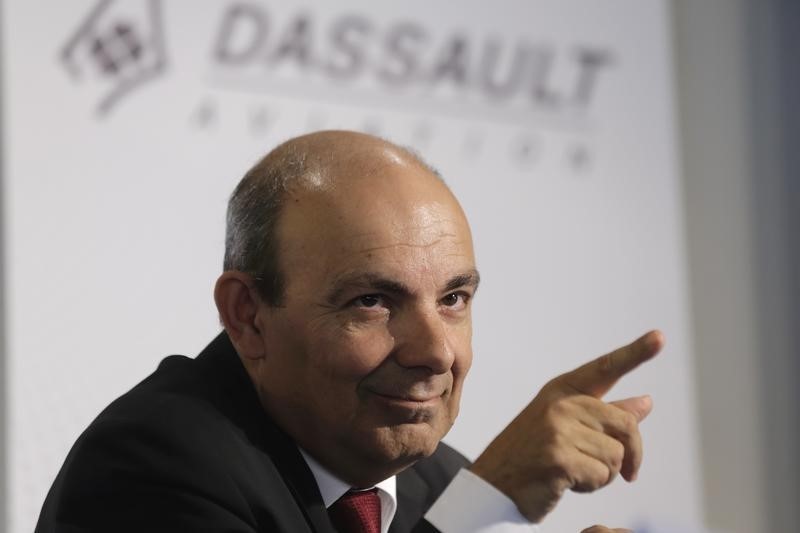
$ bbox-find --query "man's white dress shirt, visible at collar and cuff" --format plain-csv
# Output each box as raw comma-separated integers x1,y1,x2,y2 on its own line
300,449,539,533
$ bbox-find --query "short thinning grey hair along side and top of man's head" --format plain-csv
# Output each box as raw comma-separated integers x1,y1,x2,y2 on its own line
223,131,443,307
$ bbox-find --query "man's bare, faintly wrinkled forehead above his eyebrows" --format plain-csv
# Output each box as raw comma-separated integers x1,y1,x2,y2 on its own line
278,164,474,282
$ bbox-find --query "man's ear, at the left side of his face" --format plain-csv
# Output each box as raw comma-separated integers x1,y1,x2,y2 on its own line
214,270,264,359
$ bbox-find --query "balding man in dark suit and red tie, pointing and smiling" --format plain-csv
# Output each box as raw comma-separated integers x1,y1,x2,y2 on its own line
37,131,663,533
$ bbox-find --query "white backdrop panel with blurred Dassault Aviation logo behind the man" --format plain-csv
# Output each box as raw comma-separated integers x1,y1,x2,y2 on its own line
2,0,702,533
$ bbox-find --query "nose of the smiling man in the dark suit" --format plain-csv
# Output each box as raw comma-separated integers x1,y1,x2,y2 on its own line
393,309,455,374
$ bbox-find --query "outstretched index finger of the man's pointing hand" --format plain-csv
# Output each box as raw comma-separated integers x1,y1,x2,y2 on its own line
557,330,664,398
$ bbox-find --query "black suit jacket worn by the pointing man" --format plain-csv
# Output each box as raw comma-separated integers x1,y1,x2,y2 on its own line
36,333,467,533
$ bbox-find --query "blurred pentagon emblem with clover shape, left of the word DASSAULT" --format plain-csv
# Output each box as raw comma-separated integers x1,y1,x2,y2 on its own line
60,0,166,115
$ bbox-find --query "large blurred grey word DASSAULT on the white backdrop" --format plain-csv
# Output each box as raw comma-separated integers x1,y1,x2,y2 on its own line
211,1,613,119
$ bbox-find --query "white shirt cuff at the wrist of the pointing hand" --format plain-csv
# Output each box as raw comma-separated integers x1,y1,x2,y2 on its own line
425,468,539,533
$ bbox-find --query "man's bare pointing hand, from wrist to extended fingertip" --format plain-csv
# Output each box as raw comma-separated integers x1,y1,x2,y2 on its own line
471,331,664,520
